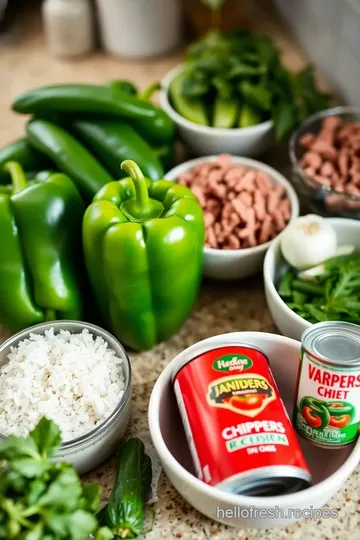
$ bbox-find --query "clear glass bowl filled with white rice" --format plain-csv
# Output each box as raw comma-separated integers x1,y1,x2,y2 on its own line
0,321,131,474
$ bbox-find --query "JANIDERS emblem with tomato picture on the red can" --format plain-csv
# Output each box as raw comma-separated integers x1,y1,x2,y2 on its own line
206,373,276,418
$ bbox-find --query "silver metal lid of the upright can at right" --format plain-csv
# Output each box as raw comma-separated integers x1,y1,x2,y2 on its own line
301,321,360,365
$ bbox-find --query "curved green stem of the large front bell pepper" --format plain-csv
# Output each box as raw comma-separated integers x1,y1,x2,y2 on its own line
120,159,164,223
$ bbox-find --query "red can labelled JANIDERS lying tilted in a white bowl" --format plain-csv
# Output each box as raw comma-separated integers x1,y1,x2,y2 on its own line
173,343,311,496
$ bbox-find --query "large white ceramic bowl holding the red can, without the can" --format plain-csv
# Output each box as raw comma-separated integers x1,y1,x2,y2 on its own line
149,332,360,528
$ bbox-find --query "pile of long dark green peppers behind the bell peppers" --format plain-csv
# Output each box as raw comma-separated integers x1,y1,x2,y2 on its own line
0,81,175,202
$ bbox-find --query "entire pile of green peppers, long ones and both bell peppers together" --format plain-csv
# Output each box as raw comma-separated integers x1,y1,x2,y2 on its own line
0,81,205,350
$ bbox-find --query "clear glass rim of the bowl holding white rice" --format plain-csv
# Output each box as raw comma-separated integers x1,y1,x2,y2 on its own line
0,319,132,452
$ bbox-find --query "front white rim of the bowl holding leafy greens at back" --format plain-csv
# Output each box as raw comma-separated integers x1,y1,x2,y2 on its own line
159,63,274,137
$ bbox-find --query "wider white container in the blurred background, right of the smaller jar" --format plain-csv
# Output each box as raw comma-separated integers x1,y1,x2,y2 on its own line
96,0,183,57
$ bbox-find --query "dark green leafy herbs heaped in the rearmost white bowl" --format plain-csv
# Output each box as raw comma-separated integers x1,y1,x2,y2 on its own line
170,29,330,141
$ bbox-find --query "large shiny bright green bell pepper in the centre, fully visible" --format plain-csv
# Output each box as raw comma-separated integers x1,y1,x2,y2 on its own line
83,160,204,350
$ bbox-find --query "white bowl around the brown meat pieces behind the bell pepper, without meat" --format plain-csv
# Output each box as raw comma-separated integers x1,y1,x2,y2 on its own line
165,156,299,281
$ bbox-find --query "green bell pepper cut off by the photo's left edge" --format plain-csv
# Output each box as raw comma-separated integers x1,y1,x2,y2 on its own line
0,162,85,332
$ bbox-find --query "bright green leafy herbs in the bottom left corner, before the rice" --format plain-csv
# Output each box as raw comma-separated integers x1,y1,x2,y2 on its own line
0,418,113,540
